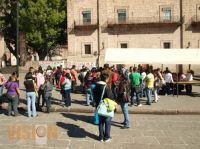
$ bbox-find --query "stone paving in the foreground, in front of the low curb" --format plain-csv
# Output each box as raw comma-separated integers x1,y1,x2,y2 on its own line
0,112,200,149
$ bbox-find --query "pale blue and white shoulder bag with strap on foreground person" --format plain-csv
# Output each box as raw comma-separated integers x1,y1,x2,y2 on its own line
97,85,114,117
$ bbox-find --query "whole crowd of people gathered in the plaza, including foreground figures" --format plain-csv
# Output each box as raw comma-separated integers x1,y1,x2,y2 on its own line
0,64,193,142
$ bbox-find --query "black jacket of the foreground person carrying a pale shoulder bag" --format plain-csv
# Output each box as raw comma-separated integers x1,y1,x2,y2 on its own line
94,81,113,108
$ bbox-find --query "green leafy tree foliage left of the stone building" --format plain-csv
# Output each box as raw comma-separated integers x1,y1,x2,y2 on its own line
2,0,67,60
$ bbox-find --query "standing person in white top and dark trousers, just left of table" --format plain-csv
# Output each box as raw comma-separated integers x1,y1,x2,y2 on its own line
164,70,174,96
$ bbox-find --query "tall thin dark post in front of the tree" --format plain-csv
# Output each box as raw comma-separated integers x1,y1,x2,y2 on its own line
16,0,19,76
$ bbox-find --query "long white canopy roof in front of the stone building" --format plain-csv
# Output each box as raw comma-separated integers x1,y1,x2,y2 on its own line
105,48,200,64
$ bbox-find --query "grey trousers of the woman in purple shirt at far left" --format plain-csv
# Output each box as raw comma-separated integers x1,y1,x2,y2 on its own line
7,95,19,116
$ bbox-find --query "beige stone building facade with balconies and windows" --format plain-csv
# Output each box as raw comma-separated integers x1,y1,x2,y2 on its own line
67,0,200,70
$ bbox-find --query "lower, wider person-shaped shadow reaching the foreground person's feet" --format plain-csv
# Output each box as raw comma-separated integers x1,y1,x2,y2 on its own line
56,122,98,140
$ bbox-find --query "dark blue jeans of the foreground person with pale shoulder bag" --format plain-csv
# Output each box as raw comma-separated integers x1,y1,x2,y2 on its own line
99,115,112,140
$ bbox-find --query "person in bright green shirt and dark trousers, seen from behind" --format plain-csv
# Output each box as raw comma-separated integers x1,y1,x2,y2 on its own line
129,67,142,107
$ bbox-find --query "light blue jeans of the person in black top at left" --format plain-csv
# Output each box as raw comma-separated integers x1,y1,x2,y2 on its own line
26,92,37,117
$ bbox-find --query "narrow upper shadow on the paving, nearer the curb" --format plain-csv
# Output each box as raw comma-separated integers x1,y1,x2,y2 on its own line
61,113,93,124
